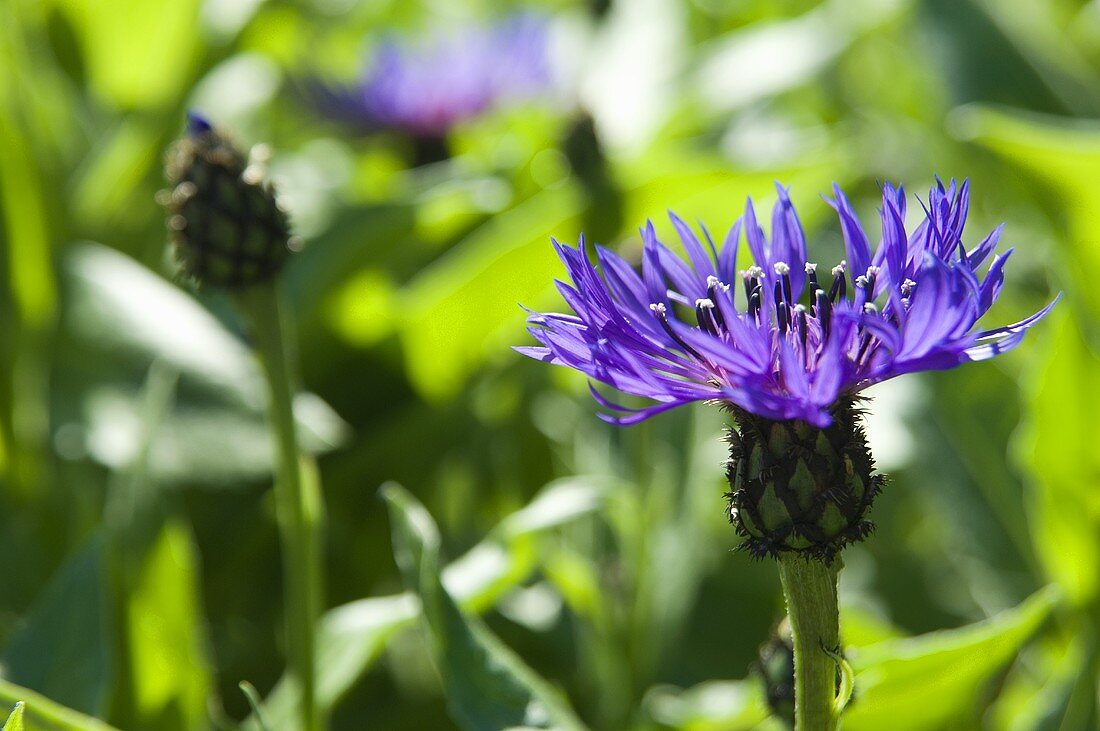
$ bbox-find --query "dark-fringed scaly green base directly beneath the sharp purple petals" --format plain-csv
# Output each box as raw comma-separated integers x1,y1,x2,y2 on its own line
726,398,884,562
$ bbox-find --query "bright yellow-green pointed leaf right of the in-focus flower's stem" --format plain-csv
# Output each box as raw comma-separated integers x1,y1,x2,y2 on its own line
844,588,1057,731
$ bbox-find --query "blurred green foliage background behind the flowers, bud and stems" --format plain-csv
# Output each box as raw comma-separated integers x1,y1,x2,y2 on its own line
0,0,1100,731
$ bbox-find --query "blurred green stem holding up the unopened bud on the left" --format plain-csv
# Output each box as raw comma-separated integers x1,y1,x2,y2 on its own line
238,283,323,731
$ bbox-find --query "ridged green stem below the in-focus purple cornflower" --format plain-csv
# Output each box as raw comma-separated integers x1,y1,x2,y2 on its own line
779,555,840,731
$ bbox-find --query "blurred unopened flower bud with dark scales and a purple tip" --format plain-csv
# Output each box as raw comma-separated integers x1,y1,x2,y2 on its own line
164,114,292,290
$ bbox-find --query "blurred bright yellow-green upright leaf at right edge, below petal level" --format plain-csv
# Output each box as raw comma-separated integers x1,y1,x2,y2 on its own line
1018,310,1100,603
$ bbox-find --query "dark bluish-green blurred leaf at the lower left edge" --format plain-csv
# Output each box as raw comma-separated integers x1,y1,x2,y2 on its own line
0,536,114,715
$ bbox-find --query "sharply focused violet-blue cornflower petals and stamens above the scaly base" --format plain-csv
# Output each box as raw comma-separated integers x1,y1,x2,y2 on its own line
517,180,1057,428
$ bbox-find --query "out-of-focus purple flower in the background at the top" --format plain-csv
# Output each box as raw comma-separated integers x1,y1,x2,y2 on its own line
316,14,551,137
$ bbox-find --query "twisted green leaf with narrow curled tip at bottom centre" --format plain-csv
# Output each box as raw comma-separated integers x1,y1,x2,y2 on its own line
383,485,584,731
